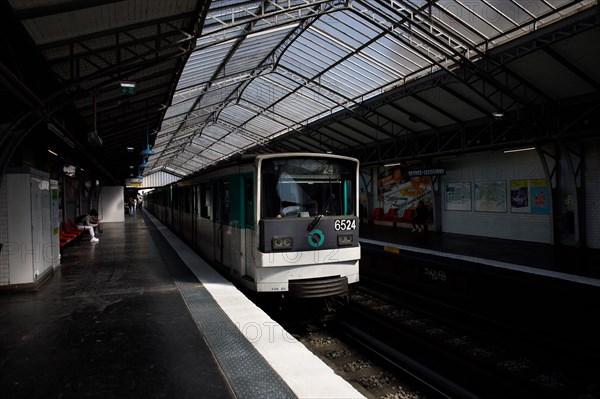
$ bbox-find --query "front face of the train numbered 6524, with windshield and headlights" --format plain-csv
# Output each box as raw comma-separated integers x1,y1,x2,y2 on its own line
248,154,360,298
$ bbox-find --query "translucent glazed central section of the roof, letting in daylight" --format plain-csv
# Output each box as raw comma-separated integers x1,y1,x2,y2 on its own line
147,0,592,177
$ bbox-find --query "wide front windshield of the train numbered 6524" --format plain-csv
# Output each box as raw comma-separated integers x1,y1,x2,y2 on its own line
261,157,357,218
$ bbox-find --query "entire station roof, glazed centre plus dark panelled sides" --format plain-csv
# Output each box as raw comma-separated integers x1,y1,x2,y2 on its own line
5,0,600,183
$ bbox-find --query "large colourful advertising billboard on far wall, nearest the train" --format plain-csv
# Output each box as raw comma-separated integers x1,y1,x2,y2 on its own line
377,166,433,216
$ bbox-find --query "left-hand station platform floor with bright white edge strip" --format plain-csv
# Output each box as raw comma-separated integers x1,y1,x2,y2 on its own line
0,211,364,399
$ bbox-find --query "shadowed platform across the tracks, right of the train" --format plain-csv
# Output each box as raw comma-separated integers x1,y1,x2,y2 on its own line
360,223,600,287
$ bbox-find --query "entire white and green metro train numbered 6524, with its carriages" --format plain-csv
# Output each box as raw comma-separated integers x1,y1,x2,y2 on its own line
144,153,360,298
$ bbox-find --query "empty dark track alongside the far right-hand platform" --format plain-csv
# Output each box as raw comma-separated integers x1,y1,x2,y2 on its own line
345,292,567,399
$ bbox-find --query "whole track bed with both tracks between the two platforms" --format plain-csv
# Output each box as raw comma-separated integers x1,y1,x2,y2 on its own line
268,282,600,399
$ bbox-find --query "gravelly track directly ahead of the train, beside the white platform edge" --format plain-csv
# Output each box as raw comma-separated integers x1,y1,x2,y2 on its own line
274,301,476,399
